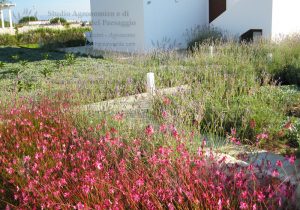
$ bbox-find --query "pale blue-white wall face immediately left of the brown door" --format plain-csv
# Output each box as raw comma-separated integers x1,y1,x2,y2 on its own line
144,0,208,50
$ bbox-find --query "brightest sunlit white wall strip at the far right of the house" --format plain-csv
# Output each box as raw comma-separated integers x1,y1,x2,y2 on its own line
272,0,300,39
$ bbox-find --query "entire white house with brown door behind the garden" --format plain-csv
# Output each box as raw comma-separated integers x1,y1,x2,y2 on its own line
91,0,300,52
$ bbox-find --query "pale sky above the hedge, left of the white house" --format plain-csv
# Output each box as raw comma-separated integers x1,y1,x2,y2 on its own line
11,0,90,20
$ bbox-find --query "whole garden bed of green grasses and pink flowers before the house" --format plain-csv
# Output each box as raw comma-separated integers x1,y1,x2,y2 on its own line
0,37,300,209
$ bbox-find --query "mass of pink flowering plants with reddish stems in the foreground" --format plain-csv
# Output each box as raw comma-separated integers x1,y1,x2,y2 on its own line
0,101,296,209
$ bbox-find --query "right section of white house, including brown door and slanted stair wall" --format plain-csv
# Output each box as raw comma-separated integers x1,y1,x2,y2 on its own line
209,0,300,40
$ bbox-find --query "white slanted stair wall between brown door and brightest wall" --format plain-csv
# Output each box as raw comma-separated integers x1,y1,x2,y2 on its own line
211,0,274,38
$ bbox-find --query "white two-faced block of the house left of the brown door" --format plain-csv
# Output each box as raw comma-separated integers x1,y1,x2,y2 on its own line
91,0,208,52
